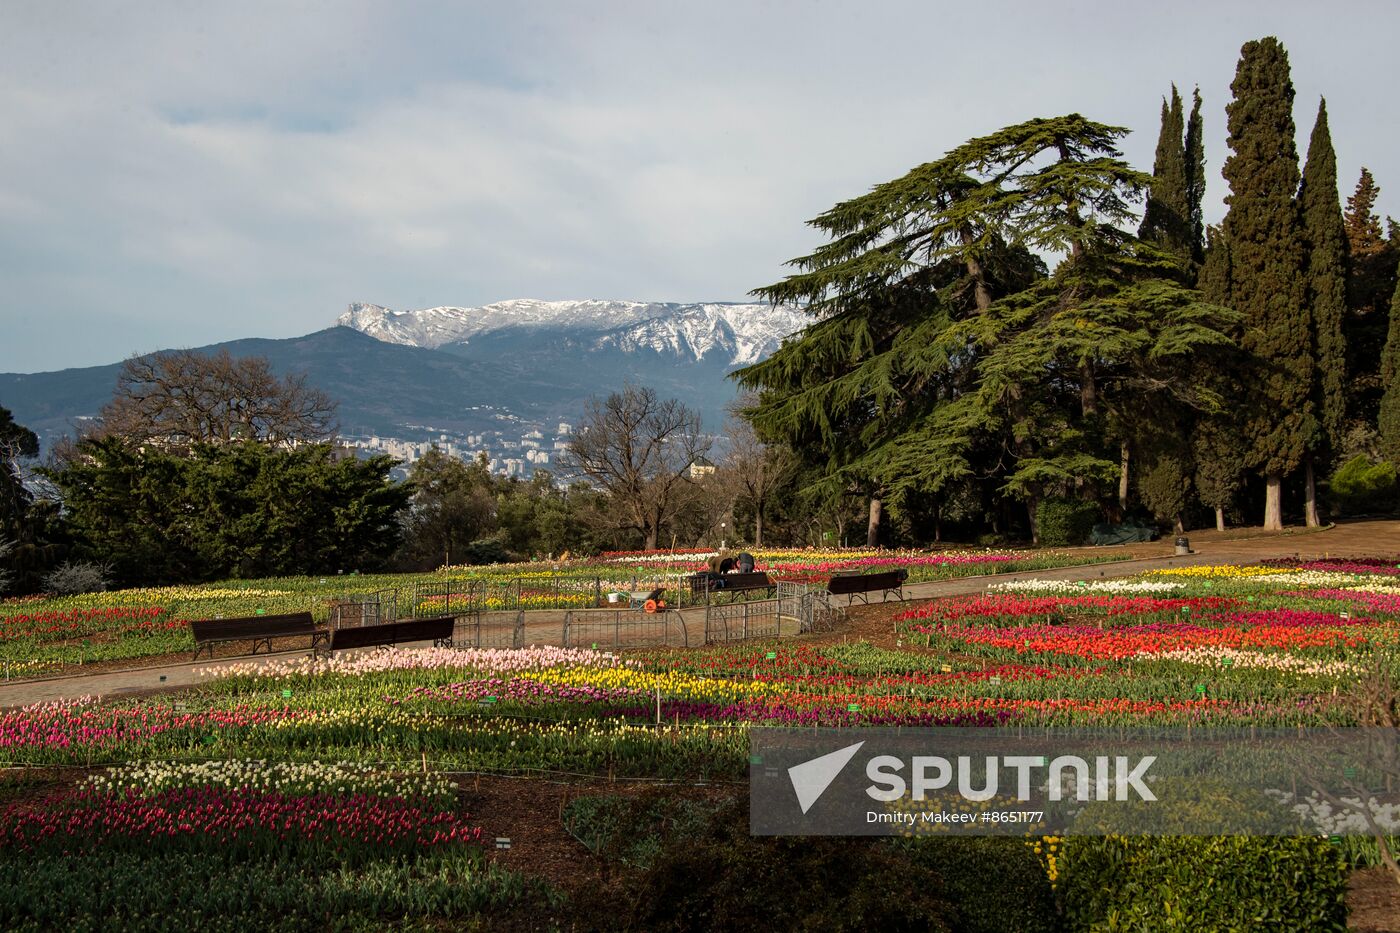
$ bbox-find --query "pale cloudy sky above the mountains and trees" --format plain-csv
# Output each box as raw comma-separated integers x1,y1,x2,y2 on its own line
0,0,1400,371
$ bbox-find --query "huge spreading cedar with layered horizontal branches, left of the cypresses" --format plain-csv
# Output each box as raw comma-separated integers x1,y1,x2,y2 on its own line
736,115,1229,546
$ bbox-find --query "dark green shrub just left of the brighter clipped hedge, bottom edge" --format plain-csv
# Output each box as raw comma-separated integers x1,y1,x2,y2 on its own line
890,836,1060,933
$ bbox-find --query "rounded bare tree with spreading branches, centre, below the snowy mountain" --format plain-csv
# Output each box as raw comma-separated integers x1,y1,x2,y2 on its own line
564,385,710,549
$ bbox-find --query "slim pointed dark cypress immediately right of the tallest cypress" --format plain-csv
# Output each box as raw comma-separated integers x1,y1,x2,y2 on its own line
1298,101,1347,525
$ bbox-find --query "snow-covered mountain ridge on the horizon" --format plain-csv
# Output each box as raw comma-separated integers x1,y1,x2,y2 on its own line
336,298,809,367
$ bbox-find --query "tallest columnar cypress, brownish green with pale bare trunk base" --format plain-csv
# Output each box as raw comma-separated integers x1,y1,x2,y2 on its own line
1224,36,1312,530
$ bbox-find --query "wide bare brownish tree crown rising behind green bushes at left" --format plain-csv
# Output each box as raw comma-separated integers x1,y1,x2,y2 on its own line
94,350,336,447
